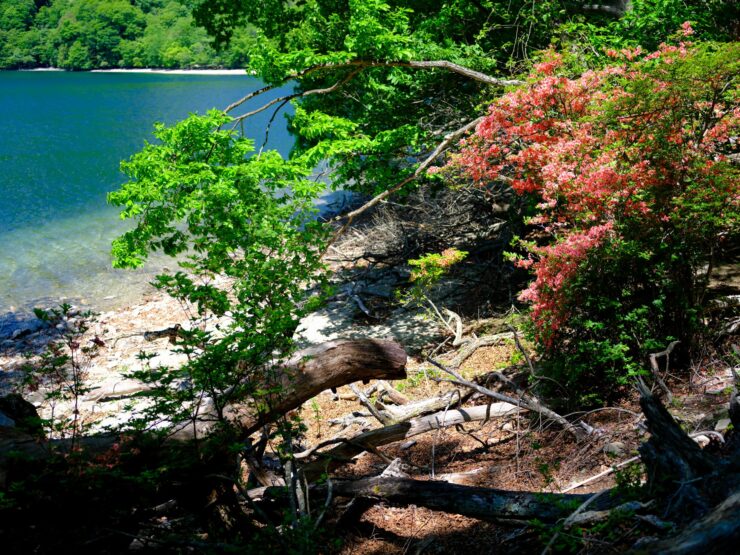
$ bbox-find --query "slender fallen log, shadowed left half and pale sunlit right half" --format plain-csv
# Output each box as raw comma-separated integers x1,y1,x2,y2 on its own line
303,403,522,481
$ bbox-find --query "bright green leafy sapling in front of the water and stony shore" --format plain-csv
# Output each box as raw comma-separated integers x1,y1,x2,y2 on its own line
109,111,326,432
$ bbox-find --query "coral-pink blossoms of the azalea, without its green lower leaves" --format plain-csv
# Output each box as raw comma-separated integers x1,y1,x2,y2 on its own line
450,34,740,346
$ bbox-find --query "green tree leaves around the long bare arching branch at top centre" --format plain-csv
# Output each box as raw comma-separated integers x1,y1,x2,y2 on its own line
194,0,652,198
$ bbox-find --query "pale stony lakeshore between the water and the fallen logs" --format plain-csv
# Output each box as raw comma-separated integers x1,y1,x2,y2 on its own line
0,256,455,431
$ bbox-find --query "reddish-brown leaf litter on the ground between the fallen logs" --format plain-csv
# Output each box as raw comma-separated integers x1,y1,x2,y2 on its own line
302,330,732,555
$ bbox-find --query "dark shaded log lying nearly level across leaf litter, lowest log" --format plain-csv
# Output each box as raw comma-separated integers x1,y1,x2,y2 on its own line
264,476,619,522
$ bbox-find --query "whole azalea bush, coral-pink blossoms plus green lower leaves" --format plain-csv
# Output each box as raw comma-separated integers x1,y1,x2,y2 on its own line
448,30,740,400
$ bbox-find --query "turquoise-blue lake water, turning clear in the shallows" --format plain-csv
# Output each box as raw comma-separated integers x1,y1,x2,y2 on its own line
0,72,293,319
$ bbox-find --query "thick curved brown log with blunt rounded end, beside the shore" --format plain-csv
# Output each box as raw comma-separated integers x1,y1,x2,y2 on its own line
172,339,406,439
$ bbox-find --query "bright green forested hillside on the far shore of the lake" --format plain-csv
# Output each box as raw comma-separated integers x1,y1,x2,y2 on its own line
0,0,254,70
